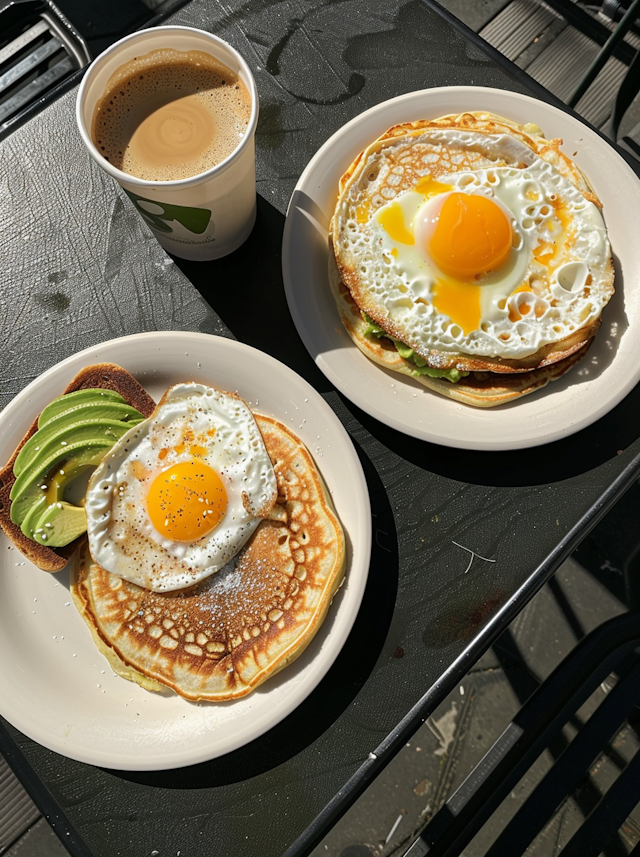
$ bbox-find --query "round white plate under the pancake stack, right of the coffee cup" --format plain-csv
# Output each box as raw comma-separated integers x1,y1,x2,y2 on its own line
282,86,640,449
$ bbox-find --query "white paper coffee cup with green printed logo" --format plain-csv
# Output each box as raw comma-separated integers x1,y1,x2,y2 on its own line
76,26,258,261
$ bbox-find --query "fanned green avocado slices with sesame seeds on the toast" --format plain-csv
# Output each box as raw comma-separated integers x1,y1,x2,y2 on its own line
10,390,144,548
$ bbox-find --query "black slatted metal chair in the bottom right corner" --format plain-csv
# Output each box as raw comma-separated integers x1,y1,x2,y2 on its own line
405,611,640,857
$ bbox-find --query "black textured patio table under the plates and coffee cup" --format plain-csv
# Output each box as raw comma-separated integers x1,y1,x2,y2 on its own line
0,0,640,857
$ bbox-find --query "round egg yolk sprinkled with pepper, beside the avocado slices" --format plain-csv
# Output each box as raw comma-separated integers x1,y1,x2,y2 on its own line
147,459,227,542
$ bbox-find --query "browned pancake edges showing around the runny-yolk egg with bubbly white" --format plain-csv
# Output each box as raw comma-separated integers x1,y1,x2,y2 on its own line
328,112,614,408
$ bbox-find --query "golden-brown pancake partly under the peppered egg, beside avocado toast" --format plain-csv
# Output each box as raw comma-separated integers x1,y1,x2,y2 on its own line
71,414,345,702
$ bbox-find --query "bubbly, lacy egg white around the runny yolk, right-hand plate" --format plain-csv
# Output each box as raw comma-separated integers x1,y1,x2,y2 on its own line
340,131,612,358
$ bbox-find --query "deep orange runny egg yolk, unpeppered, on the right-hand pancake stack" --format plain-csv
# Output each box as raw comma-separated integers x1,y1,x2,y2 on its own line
429,193,512,280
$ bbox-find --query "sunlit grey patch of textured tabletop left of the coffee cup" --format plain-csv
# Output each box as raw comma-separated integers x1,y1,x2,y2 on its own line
0,108,228,407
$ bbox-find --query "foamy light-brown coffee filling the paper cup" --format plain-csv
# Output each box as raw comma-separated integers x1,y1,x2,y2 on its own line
91,48,251,181
